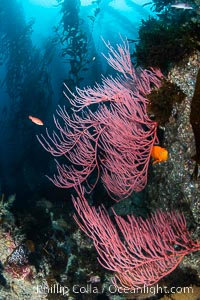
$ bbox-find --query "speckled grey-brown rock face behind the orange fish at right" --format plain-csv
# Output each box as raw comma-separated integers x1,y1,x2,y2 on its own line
147,53,200,282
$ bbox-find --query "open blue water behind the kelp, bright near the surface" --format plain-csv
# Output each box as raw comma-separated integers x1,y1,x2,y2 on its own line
0,0,151,201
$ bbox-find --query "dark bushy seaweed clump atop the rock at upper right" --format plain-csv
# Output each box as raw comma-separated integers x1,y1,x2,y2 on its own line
133,11,200,72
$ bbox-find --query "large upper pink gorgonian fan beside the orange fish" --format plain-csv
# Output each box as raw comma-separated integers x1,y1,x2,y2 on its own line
38,38,162,200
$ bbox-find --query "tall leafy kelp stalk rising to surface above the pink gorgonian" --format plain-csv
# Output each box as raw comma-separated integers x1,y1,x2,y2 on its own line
54,0,88,90
